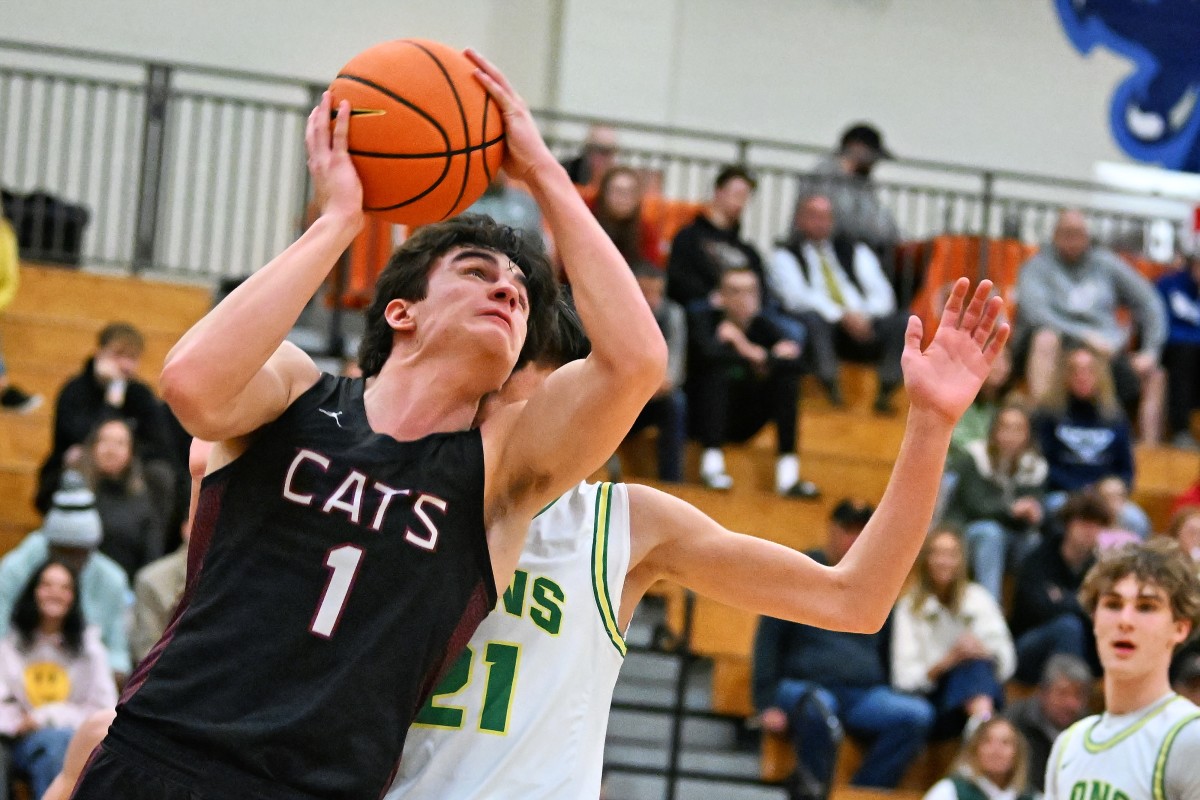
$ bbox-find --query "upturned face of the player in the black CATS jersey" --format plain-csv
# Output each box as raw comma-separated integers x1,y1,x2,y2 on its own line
413,247,529,386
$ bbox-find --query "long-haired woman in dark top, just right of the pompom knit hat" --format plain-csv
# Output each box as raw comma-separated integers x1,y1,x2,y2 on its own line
79,419,164,581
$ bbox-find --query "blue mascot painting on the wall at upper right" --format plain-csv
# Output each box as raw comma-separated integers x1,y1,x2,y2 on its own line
1055,0,1200,173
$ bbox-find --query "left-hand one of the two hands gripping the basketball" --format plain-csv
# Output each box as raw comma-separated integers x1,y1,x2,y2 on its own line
304,91,362,223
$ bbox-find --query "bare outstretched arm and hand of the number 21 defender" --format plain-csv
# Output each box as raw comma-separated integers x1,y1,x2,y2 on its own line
622,278,1008,632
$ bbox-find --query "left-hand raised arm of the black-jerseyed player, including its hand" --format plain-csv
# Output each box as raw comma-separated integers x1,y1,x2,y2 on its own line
160,92,362,441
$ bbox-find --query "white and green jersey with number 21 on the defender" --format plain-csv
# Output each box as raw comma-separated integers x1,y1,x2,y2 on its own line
386,483,629,800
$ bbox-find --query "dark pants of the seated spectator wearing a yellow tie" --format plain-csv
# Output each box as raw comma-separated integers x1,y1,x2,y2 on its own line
799,311,908,392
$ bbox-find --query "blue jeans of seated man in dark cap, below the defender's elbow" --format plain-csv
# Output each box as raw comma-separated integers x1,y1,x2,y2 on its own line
775,679,934,789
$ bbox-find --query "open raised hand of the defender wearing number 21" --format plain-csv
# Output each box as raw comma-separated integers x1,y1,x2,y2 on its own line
901,278,1009,425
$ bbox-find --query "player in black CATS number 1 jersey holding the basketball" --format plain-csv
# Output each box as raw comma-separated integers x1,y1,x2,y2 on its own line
74,53,666,800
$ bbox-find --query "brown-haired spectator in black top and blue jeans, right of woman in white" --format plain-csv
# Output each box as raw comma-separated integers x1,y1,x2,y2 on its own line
1009,491,1112,684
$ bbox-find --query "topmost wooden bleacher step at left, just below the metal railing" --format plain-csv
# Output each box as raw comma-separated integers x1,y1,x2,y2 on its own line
7,263,212,330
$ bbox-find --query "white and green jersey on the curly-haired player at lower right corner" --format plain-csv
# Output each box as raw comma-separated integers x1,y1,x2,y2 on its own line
1045,693,1200,800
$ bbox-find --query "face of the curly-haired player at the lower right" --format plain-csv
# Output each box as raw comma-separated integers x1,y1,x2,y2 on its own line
1093,575,1189,678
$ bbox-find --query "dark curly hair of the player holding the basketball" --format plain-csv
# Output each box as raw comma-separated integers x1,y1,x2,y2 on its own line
359,213,558,378
